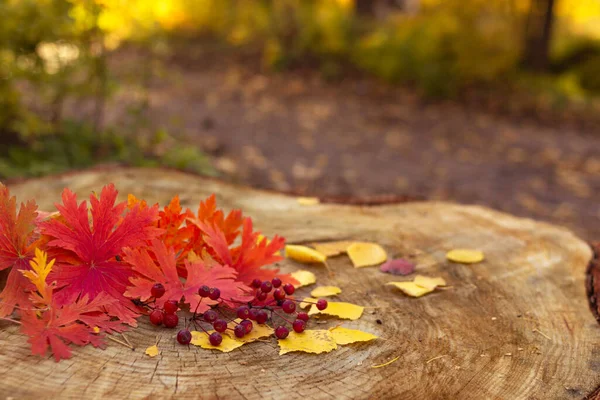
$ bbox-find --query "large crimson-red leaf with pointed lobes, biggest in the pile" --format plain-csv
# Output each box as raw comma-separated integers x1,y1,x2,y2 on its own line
40,184,162,326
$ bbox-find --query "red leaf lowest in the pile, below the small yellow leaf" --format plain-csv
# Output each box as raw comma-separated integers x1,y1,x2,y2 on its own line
21,294,125,361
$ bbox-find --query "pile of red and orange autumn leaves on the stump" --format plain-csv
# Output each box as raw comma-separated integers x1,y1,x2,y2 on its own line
0,185,296,360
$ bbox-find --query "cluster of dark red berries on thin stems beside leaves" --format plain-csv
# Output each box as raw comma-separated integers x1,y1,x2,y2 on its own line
143,277,327,346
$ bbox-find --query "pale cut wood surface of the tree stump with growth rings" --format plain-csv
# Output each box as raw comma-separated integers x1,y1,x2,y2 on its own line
0,168,600,400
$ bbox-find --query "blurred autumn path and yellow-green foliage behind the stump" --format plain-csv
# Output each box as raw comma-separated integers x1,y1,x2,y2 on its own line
0,0,600,239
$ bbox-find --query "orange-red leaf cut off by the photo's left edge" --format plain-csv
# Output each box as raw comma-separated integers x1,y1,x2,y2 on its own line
0,185,38,317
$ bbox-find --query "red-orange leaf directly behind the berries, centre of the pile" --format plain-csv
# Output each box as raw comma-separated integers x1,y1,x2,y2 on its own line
123,240,253,312
